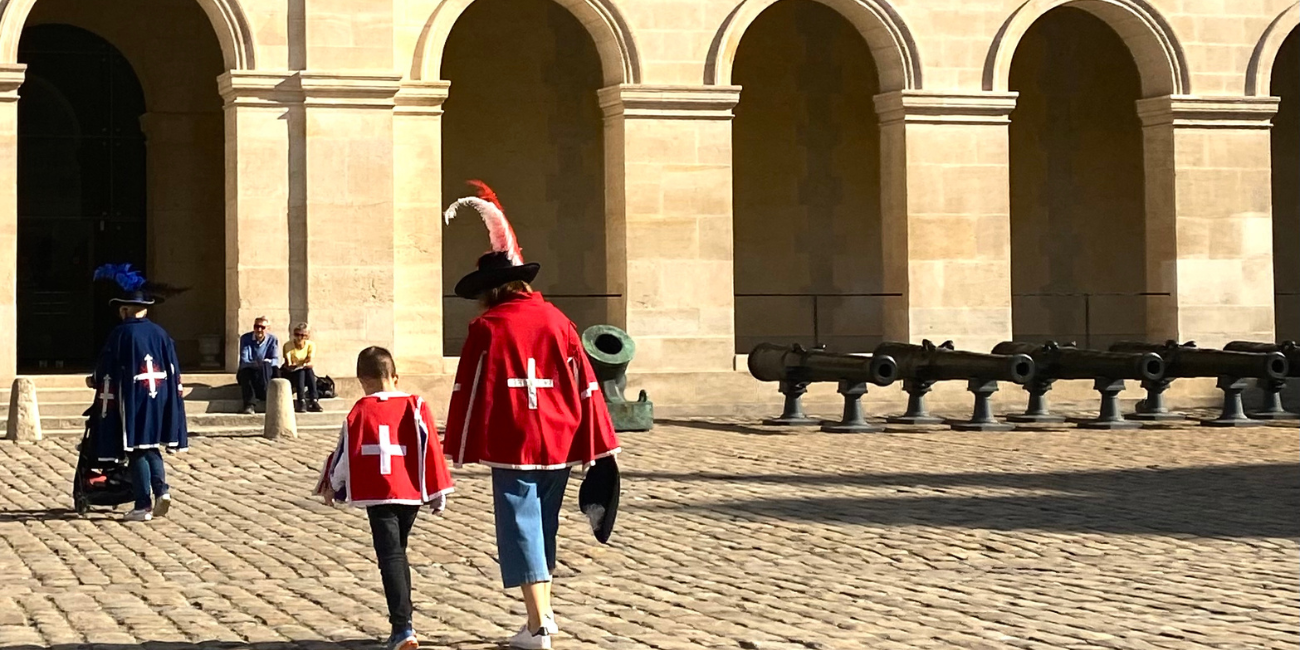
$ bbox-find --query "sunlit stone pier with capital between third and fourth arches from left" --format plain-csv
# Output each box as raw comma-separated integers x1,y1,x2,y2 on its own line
863,91,1015,351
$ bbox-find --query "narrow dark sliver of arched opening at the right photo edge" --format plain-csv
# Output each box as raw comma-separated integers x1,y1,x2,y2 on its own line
1269,30,1300,341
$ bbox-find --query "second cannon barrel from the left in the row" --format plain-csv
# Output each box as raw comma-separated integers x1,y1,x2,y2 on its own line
874,343,1034,384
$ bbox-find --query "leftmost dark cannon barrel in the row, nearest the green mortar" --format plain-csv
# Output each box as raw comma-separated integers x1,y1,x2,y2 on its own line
749,343,898,386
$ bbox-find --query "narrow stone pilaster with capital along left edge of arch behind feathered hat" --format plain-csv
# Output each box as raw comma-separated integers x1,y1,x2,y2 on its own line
393,81,456,374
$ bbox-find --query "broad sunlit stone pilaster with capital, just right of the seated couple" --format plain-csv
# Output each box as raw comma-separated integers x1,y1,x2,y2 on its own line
299,72,400,374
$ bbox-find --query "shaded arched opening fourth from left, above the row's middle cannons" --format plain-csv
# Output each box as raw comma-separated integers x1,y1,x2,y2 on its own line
1010,7,1147,348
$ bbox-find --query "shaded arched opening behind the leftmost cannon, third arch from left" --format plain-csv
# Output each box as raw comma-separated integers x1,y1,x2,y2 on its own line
732,0,883,354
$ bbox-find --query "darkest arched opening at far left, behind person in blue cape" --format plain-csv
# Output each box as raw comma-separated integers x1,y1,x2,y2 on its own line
17,0,225,372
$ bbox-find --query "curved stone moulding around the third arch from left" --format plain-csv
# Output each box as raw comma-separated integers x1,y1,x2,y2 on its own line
705,0,922,92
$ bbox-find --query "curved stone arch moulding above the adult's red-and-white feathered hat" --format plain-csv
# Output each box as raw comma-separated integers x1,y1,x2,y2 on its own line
411,0,641,86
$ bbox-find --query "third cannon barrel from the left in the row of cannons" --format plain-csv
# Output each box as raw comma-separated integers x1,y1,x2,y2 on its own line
993,341,1165,381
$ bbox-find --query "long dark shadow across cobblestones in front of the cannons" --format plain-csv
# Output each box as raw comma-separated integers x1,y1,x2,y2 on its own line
623,464,1300,538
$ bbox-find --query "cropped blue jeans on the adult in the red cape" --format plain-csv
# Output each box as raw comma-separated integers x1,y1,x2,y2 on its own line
491,468,569,589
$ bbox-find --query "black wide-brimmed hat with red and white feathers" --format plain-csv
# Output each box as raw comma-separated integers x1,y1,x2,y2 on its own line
442,181,542,300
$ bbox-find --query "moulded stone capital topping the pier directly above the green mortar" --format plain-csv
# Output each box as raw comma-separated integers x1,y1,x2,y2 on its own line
599,83,740,120
